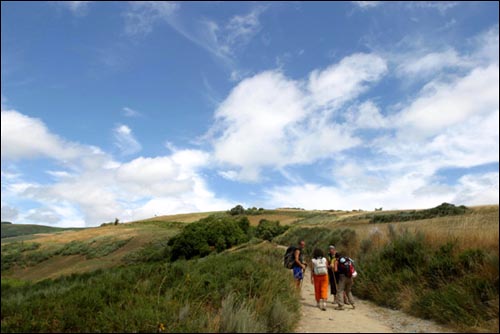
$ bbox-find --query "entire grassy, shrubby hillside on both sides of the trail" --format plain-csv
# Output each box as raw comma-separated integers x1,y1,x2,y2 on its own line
2,205,499,332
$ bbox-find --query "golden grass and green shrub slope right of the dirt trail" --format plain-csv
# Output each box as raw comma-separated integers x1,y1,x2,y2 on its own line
275,206,499,332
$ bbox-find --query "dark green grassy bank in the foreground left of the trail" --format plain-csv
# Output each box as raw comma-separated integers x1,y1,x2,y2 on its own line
1,243,300,333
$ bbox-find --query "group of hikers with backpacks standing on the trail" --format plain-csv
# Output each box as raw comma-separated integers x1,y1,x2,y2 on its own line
290,240,356,311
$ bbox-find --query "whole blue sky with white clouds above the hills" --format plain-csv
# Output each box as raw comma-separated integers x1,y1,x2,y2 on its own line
1,1,499,227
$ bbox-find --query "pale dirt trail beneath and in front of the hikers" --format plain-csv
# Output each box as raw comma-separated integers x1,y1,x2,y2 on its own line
296,272,451,333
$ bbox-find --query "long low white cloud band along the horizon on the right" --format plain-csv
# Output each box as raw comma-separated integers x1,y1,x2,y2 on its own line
267,167,499,210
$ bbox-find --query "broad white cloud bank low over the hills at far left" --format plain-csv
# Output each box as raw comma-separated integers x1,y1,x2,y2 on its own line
2,105,233,226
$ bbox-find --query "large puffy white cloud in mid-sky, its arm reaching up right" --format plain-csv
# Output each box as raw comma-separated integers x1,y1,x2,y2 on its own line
211,54,386,181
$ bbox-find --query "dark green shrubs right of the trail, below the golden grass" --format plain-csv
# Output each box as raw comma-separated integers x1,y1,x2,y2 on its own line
354,232,499,331
